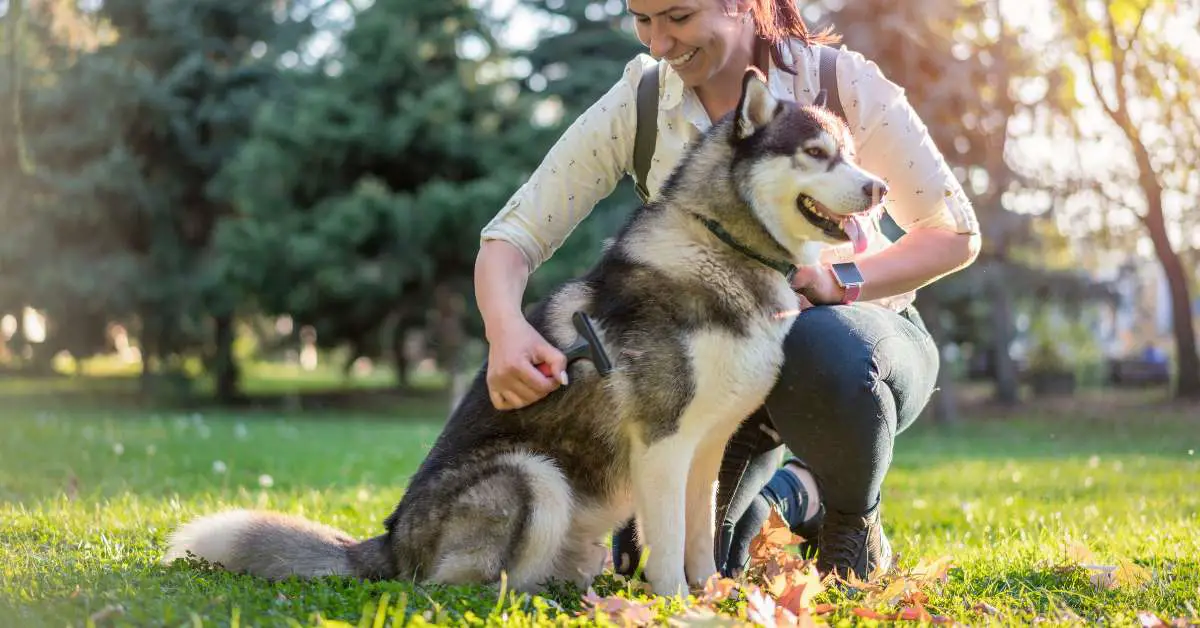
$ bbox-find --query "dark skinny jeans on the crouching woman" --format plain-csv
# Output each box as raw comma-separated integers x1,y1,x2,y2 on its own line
613,304,938,574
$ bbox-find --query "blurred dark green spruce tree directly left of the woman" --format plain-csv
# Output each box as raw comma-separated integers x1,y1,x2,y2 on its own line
217,0,540,389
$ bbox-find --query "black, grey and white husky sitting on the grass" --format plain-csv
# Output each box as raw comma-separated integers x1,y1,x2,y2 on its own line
164,71,887,596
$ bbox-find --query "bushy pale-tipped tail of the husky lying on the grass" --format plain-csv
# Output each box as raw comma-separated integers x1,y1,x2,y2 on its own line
162,510,395,580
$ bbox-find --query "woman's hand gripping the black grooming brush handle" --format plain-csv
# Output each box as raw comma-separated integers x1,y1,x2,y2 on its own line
487,316,566,409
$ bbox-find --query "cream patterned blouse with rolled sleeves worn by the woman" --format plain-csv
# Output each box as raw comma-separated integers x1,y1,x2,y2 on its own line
481,40,979,310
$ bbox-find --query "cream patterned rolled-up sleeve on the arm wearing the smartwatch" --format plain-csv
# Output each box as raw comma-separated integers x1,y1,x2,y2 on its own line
838,49,979,234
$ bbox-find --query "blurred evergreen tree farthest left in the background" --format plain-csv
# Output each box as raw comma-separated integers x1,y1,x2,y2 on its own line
5,0,305,400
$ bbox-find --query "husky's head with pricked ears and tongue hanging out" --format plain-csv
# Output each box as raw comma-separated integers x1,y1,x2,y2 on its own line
731,71,887,255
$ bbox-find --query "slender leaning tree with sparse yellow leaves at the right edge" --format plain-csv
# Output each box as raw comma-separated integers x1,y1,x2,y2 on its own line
1055,0,1200,399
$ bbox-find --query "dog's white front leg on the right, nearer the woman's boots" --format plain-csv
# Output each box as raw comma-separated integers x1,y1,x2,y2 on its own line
684,432,728,587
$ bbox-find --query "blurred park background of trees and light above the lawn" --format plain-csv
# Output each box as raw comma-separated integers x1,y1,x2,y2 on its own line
0,0,1200,420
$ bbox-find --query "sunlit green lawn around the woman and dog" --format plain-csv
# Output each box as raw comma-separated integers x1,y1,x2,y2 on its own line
0,399,1200,626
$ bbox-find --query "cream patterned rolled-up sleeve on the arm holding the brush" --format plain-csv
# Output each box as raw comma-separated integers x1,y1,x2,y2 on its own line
480,54,653,271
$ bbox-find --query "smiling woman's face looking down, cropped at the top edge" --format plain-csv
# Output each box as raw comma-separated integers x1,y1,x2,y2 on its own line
628,0,754,88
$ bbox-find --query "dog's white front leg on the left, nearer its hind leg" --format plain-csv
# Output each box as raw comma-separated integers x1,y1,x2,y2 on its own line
630,433,696,596
